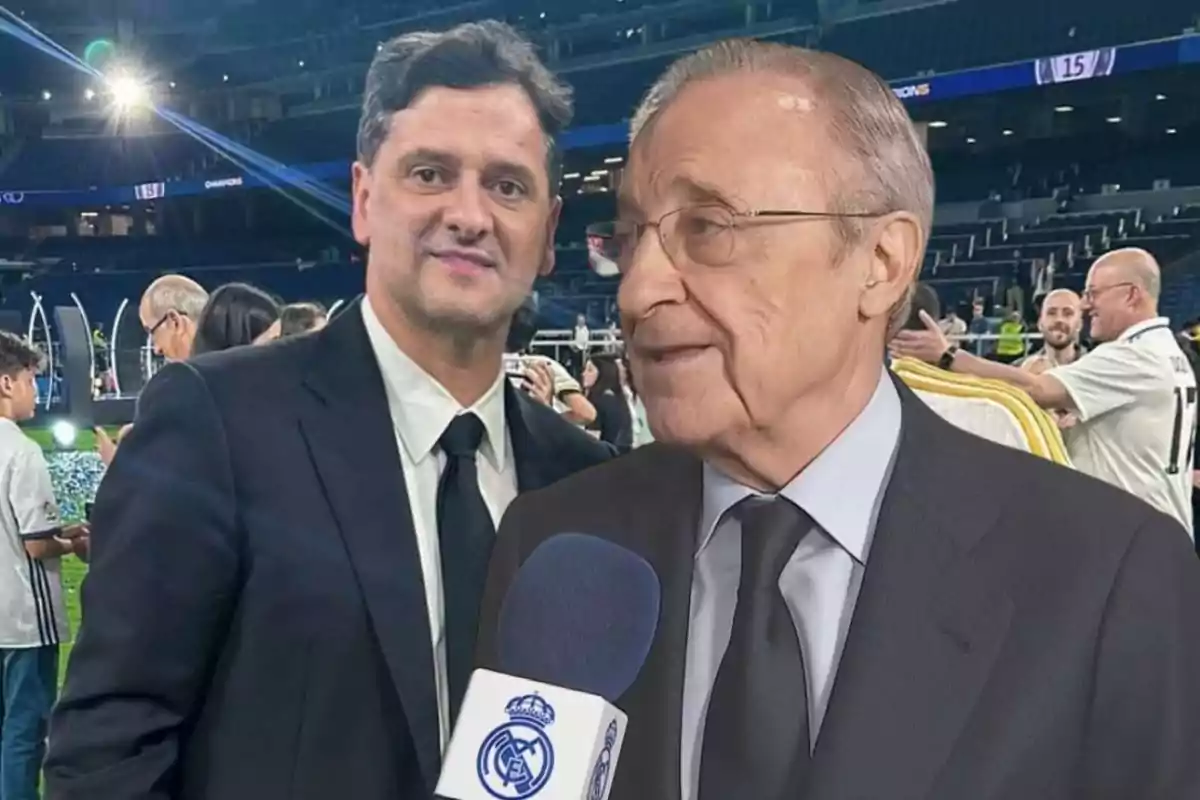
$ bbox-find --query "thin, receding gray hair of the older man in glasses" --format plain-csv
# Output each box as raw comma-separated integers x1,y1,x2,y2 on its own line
630,40,934,339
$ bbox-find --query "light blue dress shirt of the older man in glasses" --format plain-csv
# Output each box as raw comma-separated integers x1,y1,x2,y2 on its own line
680,372,900,800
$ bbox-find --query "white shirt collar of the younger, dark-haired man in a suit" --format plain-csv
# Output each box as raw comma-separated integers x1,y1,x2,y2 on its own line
362,297,508,471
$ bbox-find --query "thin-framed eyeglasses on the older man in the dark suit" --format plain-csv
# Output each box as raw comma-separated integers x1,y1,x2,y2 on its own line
587,205,888,272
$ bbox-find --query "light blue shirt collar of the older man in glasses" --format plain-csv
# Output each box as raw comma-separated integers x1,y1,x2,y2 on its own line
696,372,900,564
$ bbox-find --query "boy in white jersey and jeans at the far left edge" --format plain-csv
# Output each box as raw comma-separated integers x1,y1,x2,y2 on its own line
0,331,88,800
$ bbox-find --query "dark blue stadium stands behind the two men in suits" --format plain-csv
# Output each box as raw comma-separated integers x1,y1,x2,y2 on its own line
0,0,1200,340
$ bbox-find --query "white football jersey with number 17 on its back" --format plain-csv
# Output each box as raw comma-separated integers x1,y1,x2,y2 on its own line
1046,317,1196,536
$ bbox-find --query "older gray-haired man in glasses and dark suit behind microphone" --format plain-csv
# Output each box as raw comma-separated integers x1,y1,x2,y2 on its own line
480,41,1200,800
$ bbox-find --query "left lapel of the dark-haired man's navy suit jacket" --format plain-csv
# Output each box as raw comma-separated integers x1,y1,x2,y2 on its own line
300,305,440,790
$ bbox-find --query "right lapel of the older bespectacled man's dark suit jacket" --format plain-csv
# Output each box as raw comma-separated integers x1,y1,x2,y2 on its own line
806,387,1013,800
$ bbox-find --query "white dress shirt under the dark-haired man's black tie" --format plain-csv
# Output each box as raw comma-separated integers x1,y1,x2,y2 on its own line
362,297,517,751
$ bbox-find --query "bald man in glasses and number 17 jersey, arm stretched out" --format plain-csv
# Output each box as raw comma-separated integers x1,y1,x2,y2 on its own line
893,247,1196,535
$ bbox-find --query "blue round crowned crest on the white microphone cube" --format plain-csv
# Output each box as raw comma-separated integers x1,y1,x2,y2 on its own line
476,694,554,800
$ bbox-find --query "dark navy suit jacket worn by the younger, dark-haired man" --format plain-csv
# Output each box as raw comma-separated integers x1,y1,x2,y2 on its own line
47,303,610,800
